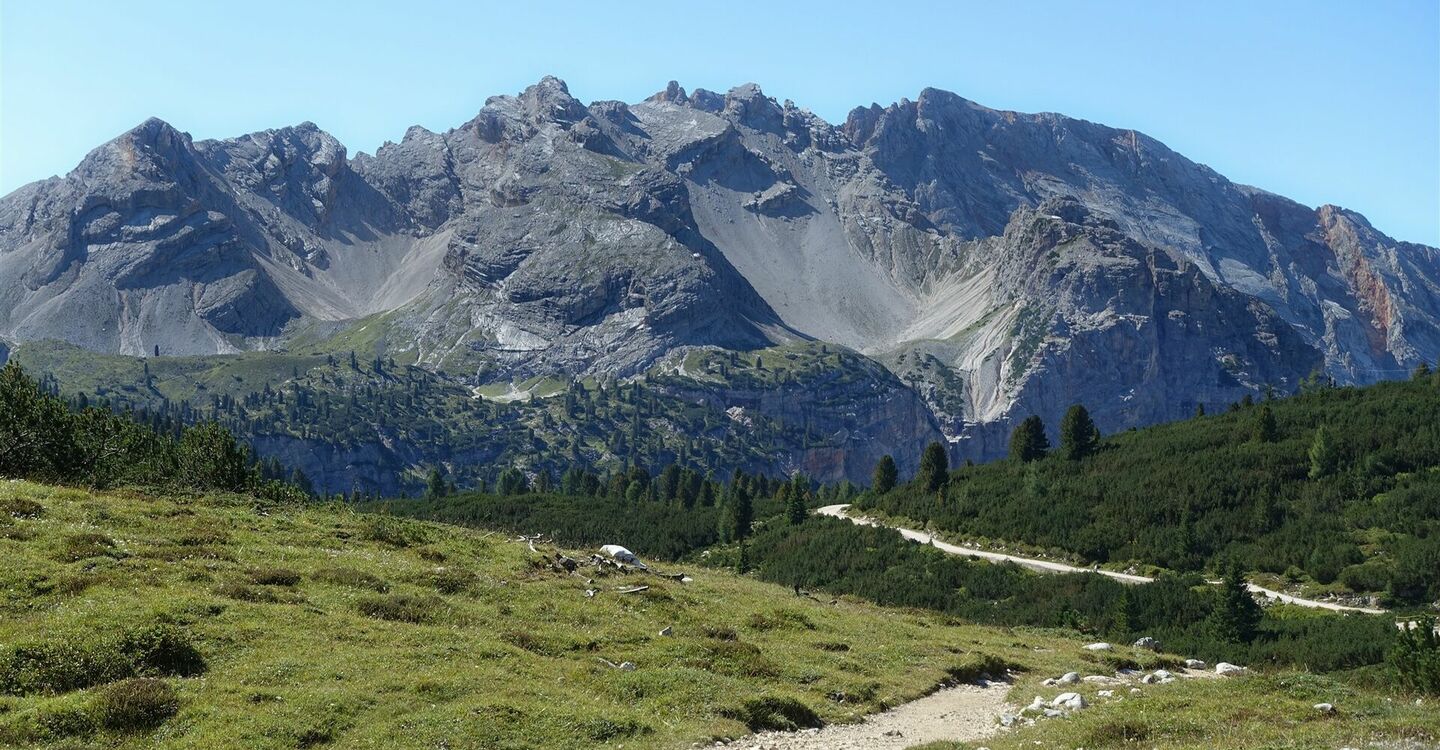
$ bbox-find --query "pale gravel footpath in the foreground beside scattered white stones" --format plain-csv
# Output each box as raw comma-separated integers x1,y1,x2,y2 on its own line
726,682,1012,750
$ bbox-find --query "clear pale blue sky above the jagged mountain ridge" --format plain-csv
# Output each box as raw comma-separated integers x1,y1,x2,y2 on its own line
0,0,1440,245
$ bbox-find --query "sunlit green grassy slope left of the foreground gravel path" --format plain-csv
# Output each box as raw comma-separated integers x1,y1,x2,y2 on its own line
0,481,1054,749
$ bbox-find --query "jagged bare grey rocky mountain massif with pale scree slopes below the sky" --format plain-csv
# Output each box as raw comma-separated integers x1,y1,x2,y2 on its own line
0,78,1440,479
